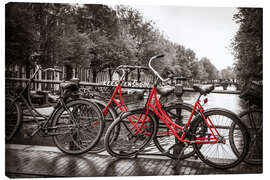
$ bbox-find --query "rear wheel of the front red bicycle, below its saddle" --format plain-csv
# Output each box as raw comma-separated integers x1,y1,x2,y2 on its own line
190,110,249,169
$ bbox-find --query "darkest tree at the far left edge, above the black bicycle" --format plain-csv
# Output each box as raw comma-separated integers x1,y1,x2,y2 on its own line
5,3,38,77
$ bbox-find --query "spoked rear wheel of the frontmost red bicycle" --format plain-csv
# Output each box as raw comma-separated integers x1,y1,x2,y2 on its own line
192,110,248,169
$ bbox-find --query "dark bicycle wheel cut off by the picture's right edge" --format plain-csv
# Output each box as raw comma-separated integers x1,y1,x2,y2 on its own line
230,109,263,165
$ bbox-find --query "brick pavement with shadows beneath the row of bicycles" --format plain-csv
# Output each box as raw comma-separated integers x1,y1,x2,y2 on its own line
6,145,262,178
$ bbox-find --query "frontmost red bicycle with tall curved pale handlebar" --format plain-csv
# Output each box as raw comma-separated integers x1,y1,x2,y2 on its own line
105,55,249,169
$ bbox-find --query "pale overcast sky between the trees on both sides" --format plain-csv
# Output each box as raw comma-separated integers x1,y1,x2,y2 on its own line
131,5,238,70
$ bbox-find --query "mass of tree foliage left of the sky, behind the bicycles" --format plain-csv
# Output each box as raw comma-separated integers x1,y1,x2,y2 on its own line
6,3,224,82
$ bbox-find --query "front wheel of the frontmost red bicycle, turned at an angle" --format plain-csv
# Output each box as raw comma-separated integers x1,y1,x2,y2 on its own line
105,109,158,158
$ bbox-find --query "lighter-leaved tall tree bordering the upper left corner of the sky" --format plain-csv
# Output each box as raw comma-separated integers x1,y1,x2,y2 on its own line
116,6,160,65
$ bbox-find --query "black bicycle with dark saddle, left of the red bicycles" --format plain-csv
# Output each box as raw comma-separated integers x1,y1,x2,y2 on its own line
5,59,104,154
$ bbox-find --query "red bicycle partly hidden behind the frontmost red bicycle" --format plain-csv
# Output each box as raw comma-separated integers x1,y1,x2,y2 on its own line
87,65,198,159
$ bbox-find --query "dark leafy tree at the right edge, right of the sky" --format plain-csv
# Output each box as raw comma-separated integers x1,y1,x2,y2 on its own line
232,8,263,80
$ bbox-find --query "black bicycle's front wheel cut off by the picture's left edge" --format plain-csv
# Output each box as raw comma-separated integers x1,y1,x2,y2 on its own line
5,97,22,141
